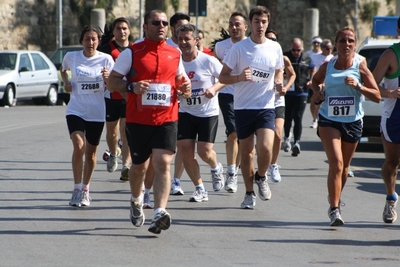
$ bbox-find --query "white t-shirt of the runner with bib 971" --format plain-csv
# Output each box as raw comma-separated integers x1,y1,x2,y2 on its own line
179,51,222,118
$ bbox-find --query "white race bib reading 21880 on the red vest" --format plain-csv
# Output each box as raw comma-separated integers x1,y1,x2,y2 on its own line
142,83,171,107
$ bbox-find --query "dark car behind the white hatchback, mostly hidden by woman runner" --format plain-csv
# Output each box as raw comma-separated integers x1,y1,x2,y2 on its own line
50,45,83,104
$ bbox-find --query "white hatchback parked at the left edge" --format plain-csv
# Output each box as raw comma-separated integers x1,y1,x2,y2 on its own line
0,50,58,107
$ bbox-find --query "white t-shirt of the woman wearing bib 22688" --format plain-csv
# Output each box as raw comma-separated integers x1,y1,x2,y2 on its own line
62,50,114,122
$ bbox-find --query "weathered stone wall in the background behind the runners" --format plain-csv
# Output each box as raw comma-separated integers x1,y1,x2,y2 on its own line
0,0,396,55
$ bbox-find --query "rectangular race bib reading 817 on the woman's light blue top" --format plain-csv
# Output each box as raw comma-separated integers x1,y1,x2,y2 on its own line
328,96,356,117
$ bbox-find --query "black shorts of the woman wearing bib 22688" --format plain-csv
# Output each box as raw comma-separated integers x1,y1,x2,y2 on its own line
65,115,104,146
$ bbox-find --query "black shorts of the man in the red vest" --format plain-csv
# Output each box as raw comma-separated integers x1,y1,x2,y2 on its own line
125,121,178,164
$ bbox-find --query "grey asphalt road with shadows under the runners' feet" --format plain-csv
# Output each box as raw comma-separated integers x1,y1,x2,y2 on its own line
0,106,400,266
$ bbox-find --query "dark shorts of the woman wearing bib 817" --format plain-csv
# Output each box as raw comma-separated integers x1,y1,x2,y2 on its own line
317,114,363,144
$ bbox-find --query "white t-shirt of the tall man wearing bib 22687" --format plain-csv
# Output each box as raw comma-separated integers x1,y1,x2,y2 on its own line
224,38,283,110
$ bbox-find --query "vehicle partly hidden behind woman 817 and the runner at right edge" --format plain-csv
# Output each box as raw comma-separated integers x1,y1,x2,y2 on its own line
357,38,399,137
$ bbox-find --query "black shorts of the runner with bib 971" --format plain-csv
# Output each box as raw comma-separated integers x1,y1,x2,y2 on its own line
178,112,218,143
